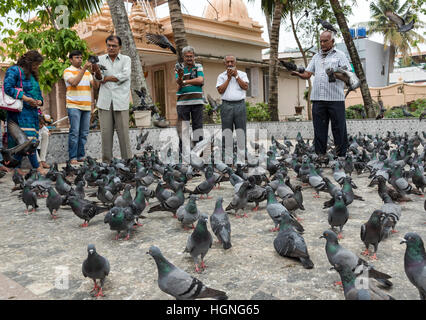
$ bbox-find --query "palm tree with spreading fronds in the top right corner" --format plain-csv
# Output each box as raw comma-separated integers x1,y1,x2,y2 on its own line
368,0,425,83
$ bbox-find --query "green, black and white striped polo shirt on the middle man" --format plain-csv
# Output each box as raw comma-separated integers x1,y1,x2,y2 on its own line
175,63,205,106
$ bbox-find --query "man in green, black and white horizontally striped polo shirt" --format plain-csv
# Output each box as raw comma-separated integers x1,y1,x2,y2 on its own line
176,46,204,161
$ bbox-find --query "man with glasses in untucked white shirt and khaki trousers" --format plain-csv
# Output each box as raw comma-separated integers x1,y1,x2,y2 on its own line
94,35,132,162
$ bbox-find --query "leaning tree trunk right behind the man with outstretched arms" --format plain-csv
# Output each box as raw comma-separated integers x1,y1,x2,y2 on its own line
330,0,376,118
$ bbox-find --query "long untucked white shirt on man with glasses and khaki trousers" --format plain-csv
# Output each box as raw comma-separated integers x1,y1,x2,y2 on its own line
93,53,132,111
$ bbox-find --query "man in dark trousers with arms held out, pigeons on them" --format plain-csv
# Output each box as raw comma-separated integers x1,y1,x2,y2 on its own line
291,31,351,158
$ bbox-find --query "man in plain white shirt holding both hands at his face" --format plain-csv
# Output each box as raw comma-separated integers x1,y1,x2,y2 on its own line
216,55,249,164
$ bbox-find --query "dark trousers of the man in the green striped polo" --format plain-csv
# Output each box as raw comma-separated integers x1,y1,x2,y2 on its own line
176,104,204,153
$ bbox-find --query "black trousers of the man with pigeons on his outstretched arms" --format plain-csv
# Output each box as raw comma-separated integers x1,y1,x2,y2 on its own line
312,101,349,157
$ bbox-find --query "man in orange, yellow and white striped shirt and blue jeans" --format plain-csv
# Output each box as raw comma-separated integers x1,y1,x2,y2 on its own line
64,50,96,164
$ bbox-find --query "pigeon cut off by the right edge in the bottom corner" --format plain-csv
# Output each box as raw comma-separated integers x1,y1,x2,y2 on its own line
400,232,426,300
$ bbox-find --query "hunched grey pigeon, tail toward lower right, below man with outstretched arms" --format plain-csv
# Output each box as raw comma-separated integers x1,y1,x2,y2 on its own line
274,215,314,269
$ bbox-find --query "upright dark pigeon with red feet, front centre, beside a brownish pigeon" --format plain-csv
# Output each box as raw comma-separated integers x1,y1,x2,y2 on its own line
183,213,213,272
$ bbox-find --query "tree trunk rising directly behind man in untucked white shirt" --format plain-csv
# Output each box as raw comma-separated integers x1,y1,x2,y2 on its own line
107,0,152,104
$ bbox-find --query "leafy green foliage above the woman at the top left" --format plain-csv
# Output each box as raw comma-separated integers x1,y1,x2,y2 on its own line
0,0,102,92
